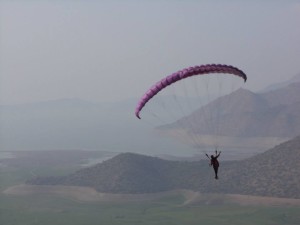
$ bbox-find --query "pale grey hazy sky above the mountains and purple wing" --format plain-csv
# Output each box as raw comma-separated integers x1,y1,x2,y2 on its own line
0,0,300,104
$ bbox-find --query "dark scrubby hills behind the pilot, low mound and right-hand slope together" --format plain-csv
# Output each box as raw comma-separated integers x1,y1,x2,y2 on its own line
27,137,300,198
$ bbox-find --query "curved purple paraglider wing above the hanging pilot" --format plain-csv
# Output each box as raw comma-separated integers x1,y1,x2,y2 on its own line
135,64,247,119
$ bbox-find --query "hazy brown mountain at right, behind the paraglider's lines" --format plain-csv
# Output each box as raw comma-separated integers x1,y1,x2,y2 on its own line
158,82,300,148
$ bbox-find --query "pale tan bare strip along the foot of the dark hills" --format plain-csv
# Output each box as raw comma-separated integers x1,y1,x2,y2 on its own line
3,184,300,206
